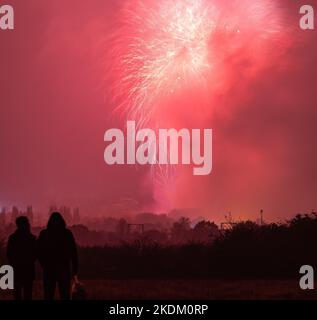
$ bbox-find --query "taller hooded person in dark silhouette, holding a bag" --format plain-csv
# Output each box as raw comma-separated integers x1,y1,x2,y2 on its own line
38,212,78,300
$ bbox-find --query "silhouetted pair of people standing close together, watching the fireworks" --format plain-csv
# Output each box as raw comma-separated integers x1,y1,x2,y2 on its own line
7,212,78,300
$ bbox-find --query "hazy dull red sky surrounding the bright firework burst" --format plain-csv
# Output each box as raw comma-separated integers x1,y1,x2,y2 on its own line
0,0,317,221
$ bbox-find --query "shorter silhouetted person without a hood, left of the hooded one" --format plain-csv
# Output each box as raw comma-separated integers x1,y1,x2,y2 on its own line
7,216,36,300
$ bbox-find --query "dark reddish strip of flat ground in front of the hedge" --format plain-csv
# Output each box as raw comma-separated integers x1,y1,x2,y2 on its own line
0,279,317,300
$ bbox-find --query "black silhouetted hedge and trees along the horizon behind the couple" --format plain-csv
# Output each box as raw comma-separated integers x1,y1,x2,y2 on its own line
0,213,317,279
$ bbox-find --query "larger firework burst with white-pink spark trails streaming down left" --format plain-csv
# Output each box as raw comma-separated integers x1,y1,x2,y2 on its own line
108,0,215,126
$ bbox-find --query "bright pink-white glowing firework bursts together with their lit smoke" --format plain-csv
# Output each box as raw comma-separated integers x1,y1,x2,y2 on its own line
107,0,282,212
